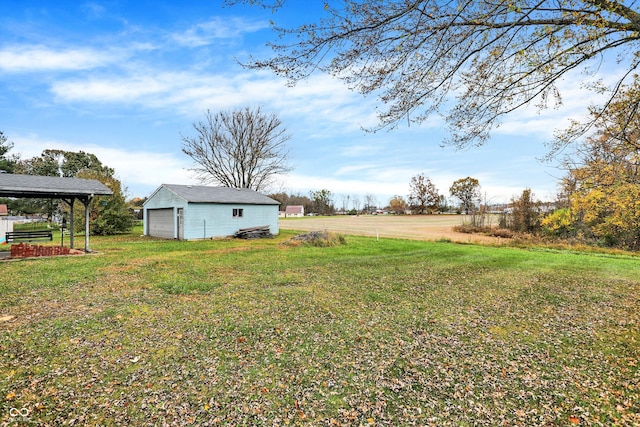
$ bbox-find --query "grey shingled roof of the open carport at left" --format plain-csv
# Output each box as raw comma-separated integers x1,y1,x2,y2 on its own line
0,173,113,199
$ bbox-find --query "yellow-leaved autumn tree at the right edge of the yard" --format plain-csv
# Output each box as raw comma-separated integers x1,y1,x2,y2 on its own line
546,84,640,249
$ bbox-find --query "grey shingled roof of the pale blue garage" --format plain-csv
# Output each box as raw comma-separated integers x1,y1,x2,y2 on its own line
156,184,280,205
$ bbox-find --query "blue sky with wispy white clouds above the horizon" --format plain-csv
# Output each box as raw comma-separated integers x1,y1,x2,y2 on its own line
0,0,608,206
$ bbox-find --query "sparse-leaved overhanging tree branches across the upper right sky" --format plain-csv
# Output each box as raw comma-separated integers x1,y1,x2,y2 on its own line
226,0,640,147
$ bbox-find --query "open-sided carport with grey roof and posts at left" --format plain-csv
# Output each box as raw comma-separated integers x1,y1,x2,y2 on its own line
0,173,113,252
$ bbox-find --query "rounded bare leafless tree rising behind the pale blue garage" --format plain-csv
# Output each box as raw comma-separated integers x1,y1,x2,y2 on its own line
182,107,291,191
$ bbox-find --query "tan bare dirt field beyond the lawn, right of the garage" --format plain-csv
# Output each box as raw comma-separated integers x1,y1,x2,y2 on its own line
280,215,505,244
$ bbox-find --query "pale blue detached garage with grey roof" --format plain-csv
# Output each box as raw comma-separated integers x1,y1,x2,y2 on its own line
143,184,280,240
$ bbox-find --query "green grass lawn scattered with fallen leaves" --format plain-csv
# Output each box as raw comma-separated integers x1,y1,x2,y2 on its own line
0,230,640,426
